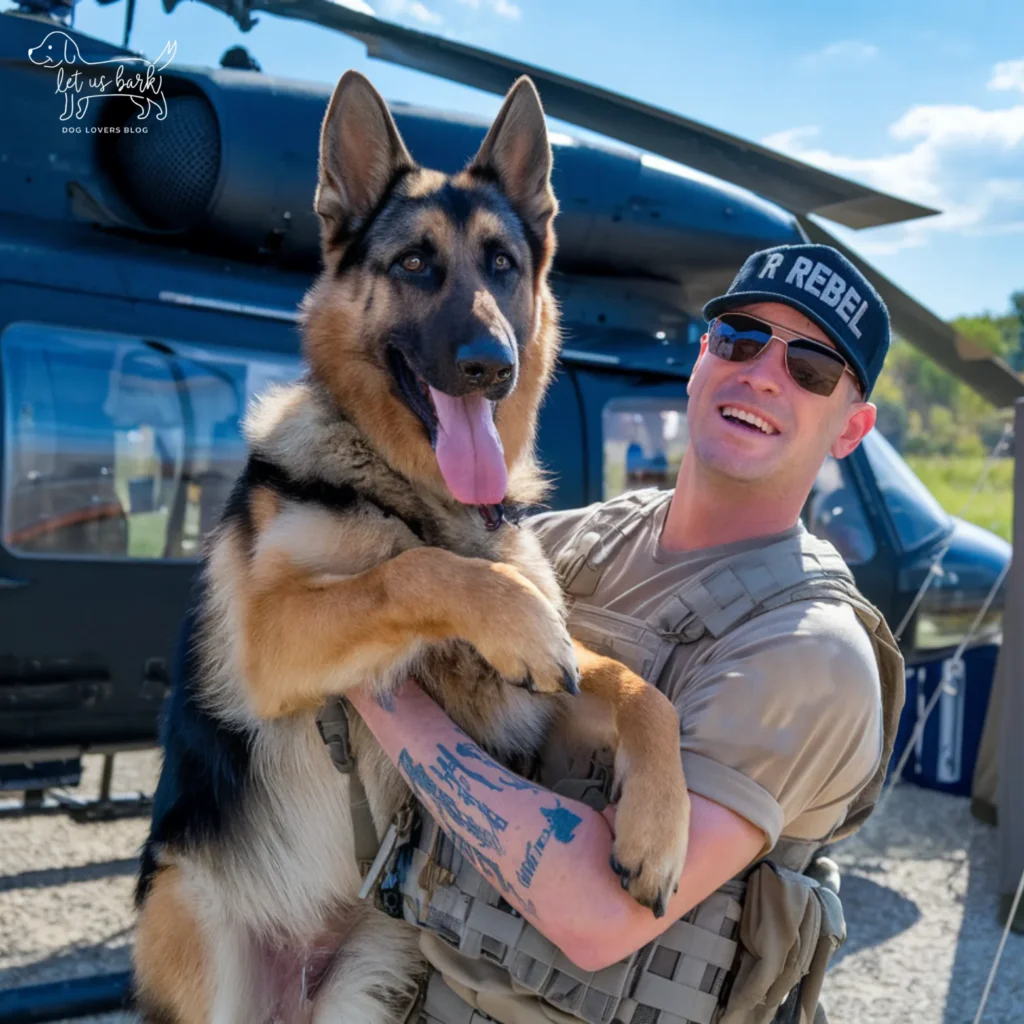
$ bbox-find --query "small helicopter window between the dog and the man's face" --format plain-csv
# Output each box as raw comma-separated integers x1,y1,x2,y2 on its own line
601,397,690,499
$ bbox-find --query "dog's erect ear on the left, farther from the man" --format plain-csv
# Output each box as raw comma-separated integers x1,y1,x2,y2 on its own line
313,71,416,233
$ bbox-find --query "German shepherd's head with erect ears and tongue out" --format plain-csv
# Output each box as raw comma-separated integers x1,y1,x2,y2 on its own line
302,72,557,504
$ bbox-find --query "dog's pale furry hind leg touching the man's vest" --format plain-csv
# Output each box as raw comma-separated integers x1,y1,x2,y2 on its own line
312,908,425,1024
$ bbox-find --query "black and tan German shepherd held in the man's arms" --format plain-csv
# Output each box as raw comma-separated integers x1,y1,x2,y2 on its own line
134,72,689,1024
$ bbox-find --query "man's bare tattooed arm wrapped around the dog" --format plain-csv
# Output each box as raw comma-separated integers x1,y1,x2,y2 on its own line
349,681,764,971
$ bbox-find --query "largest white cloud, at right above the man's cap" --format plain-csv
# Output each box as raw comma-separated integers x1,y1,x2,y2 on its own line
763,71,1024,255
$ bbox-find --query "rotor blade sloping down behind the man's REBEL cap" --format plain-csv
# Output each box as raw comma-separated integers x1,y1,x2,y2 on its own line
798,217,1024,407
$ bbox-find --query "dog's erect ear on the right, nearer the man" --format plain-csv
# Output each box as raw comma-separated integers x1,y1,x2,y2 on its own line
468,76,557,239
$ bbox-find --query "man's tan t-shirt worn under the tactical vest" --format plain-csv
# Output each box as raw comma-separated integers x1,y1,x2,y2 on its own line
527,493,882,851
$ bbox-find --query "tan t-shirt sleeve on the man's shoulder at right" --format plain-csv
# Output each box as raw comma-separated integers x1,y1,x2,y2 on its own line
667,601,882,852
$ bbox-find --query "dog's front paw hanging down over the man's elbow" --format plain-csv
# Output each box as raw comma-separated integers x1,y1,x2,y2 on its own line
611,765,690,918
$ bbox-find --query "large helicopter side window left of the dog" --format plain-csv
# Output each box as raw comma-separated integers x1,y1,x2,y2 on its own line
0,324,301,559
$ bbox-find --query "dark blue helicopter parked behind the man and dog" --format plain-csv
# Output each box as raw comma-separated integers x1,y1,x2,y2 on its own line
0,0,1024,815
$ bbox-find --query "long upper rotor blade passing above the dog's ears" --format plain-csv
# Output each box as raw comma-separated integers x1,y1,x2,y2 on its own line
180,0,938,228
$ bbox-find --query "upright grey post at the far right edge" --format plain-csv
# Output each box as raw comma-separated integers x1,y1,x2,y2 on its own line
998,398,1024,932
